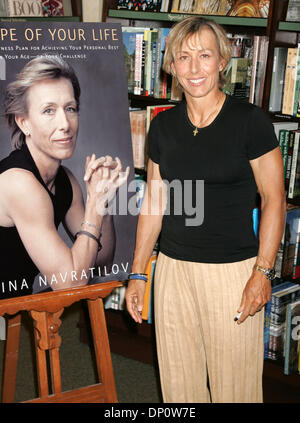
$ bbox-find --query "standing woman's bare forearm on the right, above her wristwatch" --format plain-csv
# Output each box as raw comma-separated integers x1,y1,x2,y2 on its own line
257,196,286,267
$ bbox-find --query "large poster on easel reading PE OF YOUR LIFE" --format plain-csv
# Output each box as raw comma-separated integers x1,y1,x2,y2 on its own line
0,20,138,307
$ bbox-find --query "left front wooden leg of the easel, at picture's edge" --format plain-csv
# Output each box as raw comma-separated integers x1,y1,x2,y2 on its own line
2,313,22,402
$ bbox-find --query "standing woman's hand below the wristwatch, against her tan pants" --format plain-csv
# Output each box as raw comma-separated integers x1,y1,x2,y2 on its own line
237,271,272,324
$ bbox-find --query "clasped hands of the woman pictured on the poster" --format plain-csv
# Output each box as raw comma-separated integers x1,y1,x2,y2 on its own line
83,154,130,215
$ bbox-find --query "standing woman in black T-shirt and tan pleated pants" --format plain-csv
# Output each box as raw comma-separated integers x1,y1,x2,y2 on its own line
126,16,285,402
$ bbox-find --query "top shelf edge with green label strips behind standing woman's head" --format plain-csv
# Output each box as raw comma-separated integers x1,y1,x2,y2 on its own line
108,9,267,28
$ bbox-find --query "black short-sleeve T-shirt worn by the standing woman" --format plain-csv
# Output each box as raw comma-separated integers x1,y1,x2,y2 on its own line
148,95,278,263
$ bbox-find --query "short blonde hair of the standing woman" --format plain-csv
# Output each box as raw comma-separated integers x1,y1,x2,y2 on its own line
163,16,231,88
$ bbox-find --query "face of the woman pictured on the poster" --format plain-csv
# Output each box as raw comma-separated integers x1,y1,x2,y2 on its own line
16,78,78,161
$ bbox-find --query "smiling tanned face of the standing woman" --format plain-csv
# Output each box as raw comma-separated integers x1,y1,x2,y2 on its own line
171,27,225,101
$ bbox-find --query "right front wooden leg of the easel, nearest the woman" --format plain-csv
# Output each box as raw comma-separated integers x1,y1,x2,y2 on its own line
87,298,117,402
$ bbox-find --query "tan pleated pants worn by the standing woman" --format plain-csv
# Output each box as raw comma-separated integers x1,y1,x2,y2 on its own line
154,253,264,403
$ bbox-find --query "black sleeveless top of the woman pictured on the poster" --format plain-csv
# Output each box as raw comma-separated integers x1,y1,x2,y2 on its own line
0,144,73,299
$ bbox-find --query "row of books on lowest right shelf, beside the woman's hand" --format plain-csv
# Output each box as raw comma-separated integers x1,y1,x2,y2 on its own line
264,281,300,375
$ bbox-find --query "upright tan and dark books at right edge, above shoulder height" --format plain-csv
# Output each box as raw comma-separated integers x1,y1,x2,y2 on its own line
269,43,300,117
